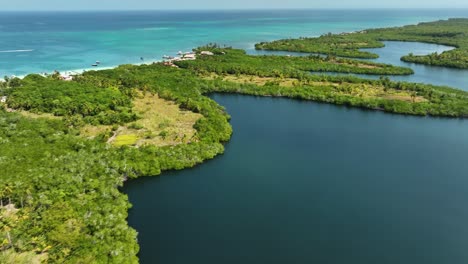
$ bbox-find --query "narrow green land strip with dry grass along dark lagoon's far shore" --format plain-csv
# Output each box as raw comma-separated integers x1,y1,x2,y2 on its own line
207,76,468,117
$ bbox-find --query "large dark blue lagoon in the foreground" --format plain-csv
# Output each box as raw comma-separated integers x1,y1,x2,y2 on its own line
125,95,468,264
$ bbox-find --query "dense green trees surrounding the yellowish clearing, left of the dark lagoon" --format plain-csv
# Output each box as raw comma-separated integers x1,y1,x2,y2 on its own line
0,65,231,263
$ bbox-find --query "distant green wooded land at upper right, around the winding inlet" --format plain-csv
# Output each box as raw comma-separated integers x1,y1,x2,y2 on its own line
256,18,468,69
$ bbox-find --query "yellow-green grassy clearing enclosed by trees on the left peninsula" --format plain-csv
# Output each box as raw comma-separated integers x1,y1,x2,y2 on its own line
81,93,202,146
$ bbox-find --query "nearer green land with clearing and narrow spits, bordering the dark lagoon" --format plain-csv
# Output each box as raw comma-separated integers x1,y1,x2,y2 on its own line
0,20,468,263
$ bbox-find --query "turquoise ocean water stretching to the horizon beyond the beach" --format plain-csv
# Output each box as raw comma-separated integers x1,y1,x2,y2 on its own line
0,10,467,76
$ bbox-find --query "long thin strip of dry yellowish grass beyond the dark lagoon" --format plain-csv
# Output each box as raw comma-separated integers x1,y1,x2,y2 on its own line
207,74,427,103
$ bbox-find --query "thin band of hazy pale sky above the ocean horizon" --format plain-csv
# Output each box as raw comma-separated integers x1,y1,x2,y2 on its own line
0,0,468,10
